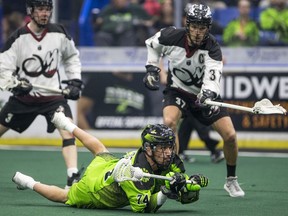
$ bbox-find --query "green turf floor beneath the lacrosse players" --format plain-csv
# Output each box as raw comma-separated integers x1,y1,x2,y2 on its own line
0,149,288,216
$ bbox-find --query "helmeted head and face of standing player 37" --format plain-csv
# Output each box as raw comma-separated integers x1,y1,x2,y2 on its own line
185,4,212,46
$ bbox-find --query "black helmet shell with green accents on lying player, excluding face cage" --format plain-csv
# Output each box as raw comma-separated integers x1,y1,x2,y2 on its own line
141,124,175,150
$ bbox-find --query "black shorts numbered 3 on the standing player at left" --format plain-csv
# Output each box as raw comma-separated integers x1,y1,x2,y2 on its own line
0,96,72,133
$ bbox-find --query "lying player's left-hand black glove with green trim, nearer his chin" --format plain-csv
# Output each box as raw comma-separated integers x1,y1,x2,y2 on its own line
160,172,186,200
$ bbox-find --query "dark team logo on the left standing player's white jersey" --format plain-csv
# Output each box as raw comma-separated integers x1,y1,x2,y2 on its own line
22,47,59,78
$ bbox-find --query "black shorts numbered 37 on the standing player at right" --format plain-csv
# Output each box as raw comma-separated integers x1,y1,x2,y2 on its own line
163,88,229,126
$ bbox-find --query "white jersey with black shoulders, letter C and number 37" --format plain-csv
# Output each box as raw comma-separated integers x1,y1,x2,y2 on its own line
145,26,223,95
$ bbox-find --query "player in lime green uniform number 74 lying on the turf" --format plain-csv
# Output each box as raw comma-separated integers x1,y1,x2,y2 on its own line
12,111,208,212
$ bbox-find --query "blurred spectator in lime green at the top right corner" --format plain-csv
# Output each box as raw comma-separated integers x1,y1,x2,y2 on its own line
259,0,288,45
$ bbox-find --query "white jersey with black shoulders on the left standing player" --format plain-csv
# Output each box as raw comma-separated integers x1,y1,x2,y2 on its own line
0,23,81,97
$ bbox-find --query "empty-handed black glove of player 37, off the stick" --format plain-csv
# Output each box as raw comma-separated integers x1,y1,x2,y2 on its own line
143,65,161,91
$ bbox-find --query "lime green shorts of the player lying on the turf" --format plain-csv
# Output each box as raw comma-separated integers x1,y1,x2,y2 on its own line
65,153,129,208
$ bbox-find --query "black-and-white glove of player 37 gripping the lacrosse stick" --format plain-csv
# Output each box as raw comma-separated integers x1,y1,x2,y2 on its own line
196,89,220,118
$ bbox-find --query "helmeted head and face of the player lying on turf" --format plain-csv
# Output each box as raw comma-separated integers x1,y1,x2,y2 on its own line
141,124,175,169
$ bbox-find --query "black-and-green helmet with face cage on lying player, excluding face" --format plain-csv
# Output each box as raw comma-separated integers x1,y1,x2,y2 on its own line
141,124,175,169
